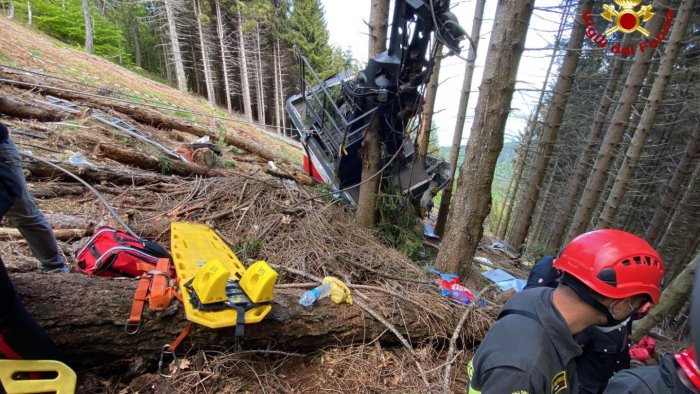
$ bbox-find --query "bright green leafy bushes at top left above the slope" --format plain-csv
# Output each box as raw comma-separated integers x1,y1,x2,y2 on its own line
15,0,131,63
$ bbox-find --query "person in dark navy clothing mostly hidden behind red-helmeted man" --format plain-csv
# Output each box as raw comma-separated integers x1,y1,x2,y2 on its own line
524,256,636,394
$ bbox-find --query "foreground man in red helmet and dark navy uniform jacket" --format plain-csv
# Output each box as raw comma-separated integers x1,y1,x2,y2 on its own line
468,229,663,394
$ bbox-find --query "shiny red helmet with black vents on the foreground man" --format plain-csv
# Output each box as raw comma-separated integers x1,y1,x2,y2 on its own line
553,229,664,304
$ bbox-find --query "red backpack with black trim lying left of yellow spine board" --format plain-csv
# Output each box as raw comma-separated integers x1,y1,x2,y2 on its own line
75,226,175,278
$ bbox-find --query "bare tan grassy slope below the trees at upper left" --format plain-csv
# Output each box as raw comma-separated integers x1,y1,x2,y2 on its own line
0,18,301,162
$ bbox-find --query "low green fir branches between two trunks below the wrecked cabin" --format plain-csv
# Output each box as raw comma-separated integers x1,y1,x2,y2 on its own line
377,188,423,260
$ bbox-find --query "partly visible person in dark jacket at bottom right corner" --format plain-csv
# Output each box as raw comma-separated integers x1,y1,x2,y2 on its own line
605,346,700,394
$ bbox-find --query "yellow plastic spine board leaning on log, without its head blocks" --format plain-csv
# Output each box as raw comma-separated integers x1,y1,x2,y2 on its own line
170,222,276,328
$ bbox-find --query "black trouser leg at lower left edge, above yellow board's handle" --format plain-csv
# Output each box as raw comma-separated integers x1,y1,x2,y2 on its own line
0,255,61,360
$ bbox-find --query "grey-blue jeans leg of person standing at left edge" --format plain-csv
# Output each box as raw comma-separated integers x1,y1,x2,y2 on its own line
0,138,65,271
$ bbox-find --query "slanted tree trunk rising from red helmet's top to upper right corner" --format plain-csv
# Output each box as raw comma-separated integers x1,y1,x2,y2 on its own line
596,0,695,228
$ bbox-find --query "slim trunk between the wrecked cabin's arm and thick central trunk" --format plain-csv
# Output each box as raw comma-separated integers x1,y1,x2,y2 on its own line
435,0,486,236
